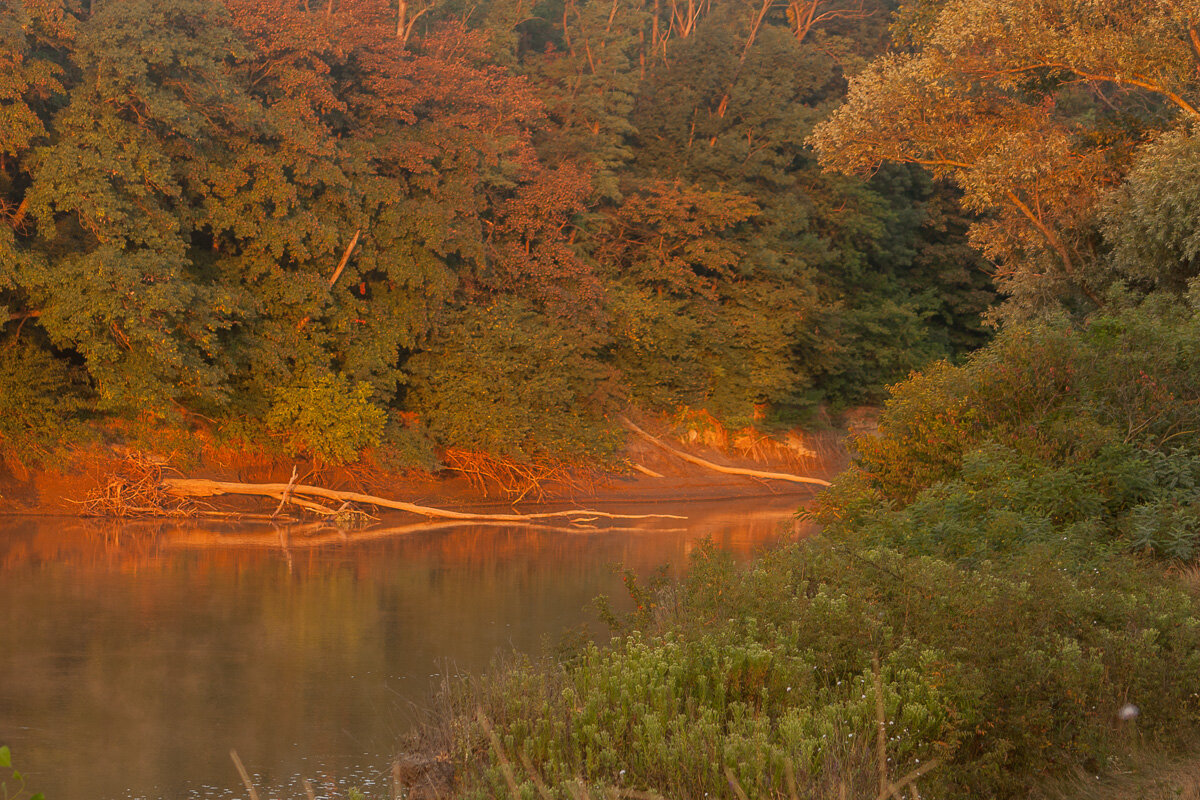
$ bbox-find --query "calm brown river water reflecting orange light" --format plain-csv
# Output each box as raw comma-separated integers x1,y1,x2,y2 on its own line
0,498,816,800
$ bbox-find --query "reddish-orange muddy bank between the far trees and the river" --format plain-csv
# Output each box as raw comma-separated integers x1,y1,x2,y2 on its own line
0,419,848,516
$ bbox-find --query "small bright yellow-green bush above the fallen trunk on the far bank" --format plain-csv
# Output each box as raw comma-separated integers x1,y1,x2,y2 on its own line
265,374,388,464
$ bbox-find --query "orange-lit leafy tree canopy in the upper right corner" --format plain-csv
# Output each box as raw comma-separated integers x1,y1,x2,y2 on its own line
812,0,1200,313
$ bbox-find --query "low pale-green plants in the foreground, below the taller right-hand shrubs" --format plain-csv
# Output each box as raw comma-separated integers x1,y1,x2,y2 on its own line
441,539,1200,798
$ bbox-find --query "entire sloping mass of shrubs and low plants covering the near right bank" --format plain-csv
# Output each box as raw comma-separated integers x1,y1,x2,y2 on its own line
410,302,1200,799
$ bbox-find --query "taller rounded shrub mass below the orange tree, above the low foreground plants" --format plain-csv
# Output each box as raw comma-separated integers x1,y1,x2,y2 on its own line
816,299,1200,558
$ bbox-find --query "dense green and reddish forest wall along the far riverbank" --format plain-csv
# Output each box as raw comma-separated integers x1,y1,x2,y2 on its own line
0,0,993,467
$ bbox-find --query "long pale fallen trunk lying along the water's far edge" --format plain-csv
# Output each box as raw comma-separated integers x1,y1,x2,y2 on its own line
161,477,686,522
